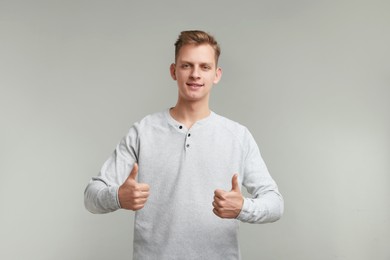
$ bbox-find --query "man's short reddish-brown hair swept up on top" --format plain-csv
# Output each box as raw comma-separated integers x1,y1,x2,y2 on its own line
175,30,221,64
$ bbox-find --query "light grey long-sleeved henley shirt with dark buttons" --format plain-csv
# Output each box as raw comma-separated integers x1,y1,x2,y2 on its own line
84,109,283,260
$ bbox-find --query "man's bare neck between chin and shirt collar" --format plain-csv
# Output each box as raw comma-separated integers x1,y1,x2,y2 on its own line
170,100,211,129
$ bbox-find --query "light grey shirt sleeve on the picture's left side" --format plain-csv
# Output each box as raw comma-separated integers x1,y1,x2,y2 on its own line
84,126,138,214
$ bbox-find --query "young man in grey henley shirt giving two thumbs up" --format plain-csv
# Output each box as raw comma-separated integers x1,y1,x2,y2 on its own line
85,31,283,260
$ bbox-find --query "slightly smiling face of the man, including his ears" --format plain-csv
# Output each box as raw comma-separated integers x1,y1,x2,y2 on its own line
170,44,222,102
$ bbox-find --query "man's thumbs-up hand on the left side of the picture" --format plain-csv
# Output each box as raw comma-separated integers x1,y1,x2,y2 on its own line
118,163,149,210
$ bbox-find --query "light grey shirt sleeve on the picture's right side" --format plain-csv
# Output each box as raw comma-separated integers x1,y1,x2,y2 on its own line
237,131,284,223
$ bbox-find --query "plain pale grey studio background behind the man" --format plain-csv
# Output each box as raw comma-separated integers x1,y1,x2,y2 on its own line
0,0,390,260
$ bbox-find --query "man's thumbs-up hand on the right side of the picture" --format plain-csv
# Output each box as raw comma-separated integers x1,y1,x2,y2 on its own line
213,174,244,218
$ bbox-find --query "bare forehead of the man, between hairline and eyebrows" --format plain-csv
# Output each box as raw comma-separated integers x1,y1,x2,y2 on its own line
177,44,215,63
